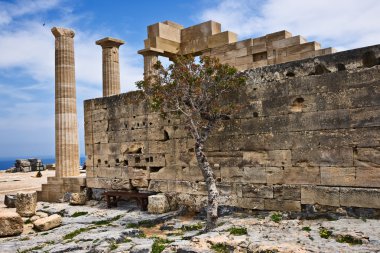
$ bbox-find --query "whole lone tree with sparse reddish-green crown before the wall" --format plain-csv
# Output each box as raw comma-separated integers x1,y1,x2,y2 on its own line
136,57,246,230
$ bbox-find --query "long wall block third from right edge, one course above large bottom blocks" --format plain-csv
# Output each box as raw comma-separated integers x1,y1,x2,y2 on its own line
266,167,320,184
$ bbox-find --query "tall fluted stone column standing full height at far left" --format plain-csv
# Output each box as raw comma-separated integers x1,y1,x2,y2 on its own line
51,27,79,178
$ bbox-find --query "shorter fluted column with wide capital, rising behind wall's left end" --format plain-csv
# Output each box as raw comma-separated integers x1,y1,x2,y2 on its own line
96,37,124,97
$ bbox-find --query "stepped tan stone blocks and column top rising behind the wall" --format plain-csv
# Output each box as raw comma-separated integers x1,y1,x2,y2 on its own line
139,21,335,75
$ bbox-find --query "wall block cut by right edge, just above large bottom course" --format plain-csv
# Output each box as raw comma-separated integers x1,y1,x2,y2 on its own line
355,167,380,187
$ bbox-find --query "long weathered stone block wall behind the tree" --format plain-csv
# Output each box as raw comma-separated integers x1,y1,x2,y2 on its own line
85,46,380,210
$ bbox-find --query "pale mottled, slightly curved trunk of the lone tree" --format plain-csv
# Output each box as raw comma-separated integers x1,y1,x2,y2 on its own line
195,140,219,231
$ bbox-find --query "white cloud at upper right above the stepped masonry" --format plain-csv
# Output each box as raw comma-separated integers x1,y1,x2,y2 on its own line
198,0,380,49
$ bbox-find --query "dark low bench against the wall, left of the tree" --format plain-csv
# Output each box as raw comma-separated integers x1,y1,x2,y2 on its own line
103,191,155,211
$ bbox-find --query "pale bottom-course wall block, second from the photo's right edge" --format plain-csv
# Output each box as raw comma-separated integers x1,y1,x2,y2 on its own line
301,185,339,206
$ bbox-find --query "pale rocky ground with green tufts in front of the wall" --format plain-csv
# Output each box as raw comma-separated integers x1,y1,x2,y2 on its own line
0,201,380,253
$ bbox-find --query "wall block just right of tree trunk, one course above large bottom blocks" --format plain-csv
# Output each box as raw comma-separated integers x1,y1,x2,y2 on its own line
221,166,267,184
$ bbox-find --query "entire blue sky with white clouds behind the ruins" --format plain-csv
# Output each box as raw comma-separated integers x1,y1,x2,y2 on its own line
0,0,380,158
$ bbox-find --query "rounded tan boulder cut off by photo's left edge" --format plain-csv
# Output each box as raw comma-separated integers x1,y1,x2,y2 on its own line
0,210,24,237
